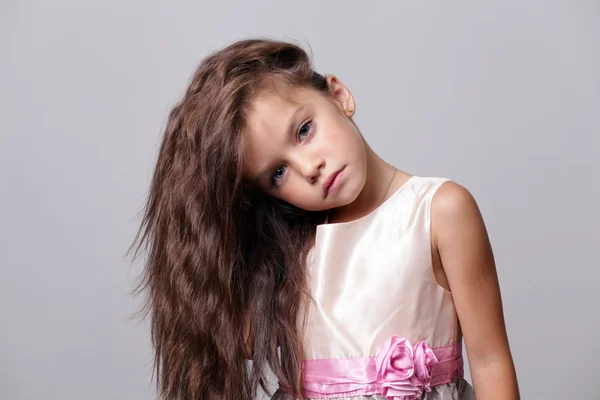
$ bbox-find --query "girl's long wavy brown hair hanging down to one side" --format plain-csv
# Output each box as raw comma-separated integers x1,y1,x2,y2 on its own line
130,39,328,400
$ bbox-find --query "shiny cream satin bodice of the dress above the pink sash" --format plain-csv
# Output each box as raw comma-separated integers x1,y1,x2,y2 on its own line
302,176,474,398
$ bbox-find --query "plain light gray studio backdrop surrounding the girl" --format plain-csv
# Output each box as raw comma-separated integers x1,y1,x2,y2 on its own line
0,0,600,400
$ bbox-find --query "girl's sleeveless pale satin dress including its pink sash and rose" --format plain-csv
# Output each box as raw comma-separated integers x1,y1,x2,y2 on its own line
302,176,474,400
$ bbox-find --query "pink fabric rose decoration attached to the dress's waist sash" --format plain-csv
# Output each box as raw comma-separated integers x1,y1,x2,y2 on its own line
376,336,437,400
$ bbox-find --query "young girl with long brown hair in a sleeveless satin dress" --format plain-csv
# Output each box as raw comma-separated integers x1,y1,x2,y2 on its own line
136,40,519,400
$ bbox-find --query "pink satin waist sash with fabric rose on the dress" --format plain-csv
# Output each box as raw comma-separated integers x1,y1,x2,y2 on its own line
302,336,463,400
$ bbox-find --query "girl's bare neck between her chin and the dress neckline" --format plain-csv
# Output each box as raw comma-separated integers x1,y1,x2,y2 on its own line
329,143,406,222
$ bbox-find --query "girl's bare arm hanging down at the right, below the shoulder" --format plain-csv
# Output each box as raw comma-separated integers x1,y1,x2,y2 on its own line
431,182,519,400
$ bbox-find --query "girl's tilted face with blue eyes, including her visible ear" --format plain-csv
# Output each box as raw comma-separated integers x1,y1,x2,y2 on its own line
244,76,367,211
